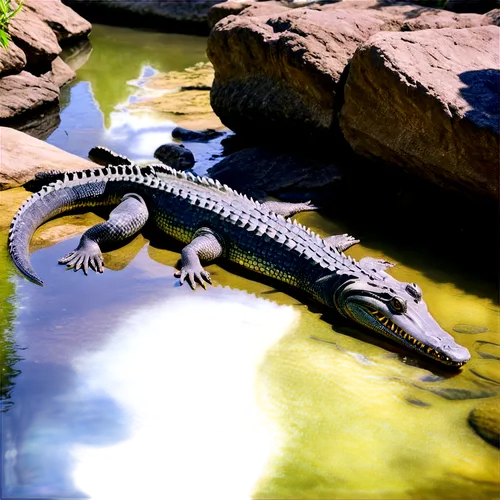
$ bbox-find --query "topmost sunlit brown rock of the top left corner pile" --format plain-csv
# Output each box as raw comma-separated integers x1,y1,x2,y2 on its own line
23,0,92,41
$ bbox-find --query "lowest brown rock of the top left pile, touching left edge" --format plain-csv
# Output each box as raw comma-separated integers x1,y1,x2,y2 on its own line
0,71,59,122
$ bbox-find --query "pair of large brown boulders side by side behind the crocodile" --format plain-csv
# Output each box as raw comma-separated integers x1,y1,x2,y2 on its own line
207,0,500,201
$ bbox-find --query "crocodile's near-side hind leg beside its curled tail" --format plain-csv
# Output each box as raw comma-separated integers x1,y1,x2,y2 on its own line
59,193,149,274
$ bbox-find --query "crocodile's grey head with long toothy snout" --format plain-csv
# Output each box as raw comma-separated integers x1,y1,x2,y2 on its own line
334,276,470,367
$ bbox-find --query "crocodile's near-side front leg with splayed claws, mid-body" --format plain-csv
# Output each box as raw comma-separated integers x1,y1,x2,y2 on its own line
174,227,224,290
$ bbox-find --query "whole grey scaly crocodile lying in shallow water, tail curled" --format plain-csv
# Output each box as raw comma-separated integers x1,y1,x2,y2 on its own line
8,146,470,369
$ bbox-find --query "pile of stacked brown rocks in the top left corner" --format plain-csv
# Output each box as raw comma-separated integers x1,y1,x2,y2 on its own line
0,0,92,125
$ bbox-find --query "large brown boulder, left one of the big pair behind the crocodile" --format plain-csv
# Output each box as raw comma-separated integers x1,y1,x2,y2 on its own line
207,9,394,140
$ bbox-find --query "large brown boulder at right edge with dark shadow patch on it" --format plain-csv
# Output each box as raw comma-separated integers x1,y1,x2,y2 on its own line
340,26,500,199
